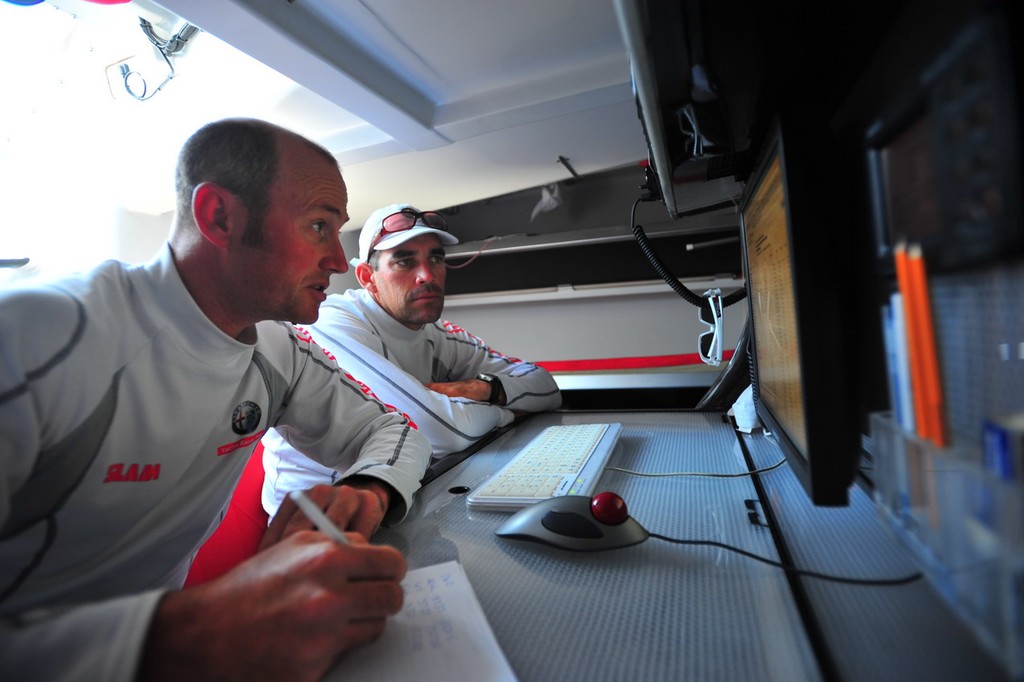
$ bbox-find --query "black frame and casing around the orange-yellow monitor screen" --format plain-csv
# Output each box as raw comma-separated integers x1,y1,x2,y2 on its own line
739,120,861,506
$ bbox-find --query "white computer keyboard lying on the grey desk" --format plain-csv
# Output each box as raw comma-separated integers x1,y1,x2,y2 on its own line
466,424,623,511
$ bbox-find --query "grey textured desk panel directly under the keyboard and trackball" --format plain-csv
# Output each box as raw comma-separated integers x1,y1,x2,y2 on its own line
375,413,820,682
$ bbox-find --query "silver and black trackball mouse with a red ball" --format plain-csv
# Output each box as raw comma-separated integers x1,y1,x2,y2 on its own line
495,493,648,552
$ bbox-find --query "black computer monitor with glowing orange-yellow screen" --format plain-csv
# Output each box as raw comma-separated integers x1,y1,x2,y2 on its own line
740,123,860,506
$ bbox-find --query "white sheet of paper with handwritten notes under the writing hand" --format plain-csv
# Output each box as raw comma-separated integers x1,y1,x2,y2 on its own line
325,561,516,682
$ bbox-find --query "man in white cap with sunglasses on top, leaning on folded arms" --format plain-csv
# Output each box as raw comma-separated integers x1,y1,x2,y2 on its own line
263,204,561,517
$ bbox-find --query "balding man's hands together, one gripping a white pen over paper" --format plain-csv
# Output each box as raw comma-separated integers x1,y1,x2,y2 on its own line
139,485,407,680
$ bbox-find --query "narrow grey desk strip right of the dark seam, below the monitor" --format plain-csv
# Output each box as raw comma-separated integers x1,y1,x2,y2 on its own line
743,433,1009,682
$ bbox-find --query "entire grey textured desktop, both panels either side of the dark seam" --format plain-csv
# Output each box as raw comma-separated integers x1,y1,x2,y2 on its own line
375,405,1008,682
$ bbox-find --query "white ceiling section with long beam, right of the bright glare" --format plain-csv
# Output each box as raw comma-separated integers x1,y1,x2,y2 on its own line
151,0,646,223
